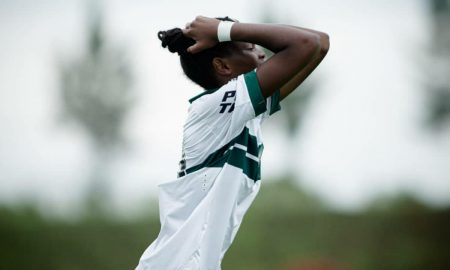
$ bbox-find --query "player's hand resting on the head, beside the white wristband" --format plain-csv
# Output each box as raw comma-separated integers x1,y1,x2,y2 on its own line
182,16,220,54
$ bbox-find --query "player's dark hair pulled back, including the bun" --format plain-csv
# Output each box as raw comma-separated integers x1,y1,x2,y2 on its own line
158,17,235,89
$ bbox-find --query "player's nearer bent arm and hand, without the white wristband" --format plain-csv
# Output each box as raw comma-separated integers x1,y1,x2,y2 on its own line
184,16,320,98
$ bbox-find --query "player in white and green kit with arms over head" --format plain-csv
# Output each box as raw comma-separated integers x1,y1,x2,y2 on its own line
136,16,329,270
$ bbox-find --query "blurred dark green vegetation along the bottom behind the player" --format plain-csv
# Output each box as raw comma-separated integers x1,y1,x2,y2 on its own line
0,179,450,270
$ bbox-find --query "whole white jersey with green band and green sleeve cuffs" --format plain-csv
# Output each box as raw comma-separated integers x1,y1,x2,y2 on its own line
136,71,280,270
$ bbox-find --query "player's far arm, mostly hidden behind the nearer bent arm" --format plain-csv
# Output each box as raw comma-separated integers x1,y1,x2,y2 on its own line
280,27,330,100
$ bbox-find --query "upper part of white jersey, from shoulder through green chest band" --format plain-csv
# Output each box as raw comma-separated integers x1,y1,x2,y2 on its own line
179,71,280,181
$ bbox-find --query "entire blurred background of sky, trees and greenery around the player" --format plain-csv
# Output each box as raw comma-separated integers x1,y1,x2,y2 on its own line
0,0,450,270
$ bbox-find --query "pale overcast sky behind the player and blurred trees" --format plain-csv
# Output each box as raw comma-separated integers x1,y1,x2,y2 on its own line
0,0,450,216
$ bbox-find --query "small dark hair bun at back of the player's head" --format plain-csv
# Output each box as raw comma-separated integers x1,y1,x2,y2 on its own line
158,28,195,55
